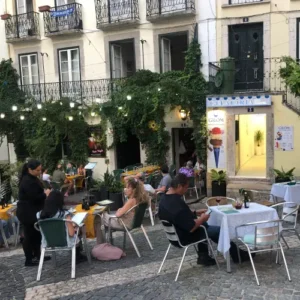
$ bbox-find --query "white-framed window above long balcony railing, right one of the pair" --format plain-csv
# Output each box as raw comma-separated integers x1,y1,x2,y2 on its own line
58,48,80,82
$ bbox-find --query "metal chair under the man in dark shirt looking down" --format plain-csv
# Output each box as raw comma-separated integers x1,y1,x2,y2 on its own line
157,220,220,281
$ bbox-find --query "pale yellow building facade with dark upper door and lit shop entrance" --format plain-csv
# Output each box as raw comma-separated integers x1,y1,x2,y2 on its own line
207,0,300,192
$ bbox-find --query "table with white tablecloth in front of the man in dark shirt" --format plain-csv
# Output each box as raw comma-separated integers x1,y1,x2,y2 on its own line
208,202,279,273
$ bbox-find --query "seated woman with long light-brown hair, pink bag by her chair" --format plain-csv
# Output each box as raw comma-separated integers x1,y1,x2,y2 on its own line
103,178,149,230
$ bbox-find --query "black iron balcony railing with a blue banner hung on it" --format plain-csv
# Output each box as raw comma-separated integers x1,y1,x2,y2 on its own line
44,3,82,36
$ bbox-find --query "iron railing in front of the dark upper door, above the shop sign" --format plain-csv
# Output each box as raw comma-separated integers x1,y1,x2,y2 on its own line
209,58,287,94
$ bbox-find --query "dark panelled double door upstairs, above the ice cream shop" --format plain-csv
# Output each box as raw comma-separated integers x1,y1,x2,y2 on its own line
229,23,264,91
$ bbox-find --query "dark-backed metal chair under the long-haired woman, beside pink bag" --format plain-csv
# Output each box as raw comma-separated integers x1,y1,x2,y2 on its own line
106,202,153,257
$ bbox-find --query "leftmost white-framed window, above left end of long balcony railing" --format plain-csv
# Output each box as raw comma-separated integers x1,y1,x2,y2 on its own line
20,53,39,85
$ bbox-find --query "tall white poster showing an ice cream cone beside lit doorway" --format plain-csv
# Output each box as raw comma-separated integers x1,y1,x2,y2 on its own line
207,111,226,169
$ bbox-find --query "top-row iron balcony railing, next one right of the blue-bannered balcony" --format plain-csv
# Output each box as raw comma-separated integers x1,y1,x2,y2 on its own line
95,0,139,29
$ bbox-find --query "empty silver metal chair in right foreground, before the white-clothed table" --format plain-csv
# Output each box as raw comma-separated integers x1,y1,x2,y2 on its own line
236,220,291,285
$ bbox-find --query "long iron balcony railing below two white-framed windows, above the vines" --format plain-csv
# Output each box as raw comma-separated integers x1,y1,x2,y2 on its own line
20,79,116,104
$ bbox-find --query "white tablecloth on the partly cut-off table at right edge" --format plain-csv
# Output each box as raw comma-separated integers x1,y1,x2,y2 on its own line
271,183,300,204
